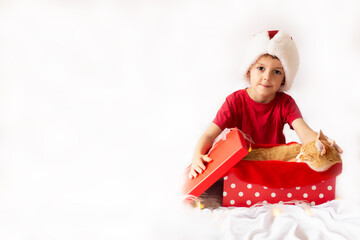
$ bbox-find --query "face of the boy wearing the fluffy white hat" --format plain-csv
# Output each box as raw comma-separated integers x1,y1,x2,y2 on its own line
248,55,285,103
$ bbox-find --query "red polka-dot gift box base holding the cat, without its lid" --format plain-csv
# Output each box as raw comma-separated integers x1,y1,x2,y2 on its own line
223,143,342,207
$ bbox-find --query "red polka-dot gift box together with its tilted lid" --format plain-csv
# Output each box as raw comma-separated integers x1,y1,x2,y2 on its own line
183,128,342,207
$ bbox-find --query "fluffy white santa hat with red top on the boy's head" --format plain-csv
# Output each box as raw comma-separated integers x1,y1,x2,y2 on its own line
242,30,299,92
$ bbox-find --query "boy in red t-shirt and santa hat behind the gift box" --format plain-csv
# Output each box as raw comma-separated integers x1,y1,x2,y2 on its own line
189,31,342,179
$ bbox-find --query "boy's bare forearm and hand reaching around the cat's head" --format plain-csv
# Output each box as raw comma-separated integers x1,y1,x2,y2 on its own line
291,118,343,153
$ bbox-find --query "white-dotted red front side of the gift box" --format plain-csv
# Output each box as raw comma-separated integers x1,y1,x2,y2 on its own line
223,174,336,207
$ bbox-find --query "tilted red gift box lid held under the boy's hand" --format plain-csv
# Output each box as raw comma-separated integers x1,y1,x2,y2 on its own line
183,128,248,200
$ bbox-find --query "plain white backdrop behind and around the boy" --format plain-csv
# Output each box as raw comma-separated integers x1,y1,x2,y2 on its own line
0,0,360,239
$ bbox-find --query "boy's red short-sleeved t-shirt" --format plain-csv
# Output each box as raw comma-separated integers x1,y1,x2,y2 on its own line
213,89,302,144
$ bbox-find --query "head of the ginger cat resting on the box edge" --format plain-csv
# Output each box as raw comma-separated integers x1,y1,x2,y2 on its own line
296,130,341,172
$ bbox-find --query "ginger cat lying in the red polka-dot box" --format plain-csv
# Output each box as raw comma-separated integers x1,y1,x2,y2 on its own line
243,130,342,172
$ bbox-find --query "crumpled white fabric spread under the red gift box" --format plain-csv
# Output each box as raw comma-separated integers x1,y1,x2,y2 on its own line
197,200,360,240
